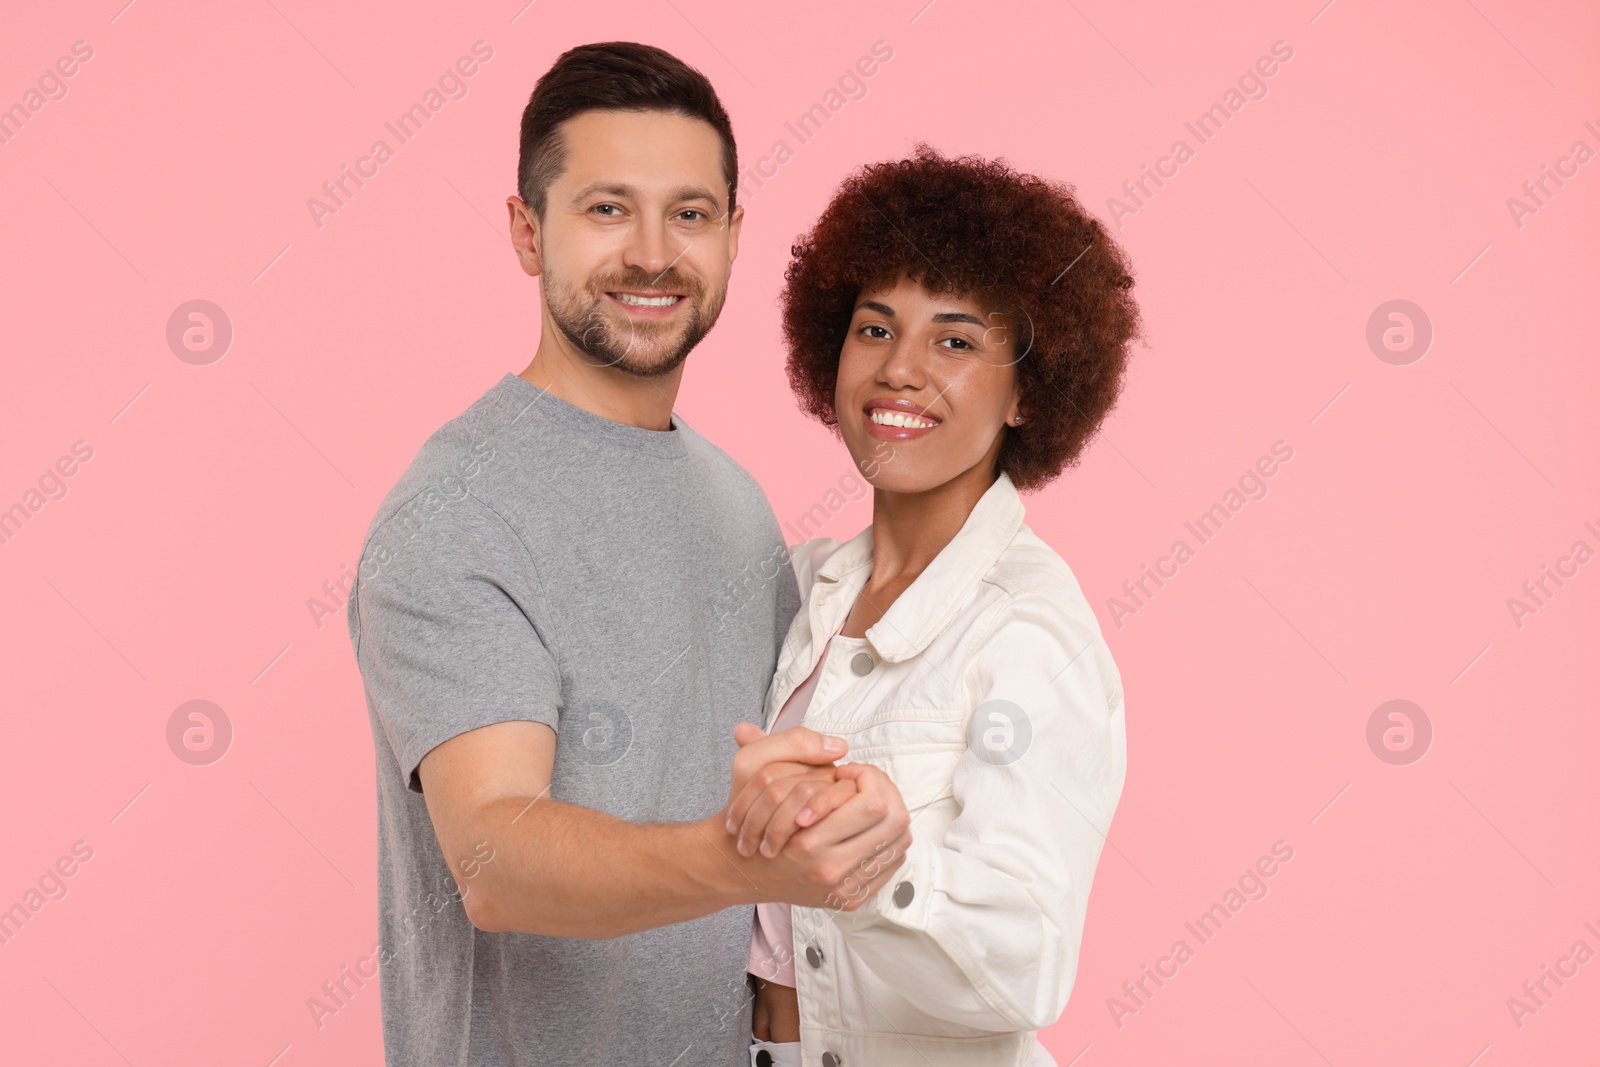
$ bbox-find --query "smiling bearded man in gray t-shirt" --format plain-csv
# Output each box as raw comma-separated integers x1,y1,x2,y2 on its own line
349,43,909,1067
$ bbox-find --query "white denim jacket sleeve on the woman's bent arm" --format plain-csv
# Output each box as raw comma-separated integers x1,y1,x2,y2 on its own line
830,595,1126,1032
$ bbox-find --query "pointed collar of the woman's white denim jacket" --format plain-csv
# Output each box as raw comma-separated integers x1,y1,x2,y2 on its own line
813,472,1024,664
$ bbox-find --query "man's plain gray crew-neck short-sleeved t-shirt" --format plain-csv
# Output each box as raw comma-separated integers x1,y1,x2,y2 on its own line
349,374,798,1067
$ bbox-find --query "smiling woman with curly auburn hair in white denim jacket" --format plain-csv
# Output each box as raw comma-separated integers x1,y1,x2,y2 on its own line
728,146,1139,1067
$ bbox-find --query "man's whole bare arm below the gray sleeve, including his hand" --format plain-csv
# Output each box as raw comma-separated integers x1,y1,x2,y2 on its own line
435,723,910,939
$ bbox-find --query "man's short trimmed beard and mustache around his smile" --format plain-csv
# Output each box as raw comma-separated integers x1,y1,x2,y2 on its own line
544,267,728,378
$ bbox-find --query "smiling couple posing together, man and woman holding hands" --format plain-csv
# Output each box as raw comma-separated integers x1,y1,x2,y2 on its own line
349,43,1138,1067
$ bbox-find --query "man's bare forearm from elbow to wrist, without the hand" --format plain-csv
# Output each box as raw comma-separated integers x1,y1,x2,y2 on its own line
451,797,765,937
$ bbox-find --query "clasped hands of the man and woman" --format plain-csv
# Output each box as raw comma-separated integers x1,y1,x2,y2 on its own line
714,723,910,912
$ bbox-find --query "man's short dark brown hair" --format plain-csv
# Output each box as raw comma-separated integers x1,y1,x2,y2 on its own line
517,42,739,219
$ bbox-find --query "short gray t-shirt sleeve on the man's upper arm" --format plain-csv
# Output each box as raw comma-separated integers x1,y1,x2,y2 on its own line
350,493,560,792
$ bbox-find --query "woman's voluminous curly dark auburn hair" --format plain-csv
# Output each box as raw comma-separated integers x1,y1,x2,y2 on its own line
781,144,1141,490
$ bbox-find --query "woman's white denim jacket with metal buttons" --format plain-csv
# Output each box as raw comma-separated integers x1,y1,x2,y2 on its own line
766,474,1126,1067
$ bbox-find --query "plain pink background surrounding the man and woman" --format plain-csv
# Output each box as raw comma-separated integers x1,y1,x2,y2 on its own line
0,0,1600,1067
